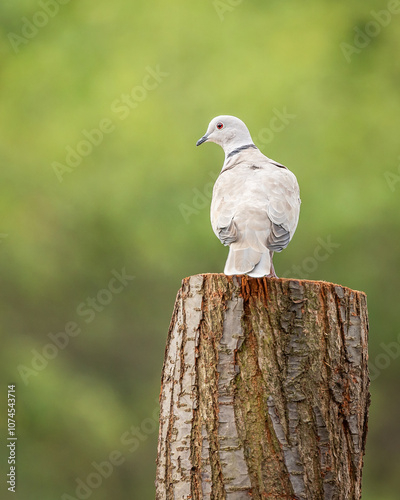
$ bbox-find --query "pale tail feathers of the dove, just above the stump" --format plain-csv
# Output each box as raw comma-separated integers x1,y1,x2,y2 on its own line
224,245,275,278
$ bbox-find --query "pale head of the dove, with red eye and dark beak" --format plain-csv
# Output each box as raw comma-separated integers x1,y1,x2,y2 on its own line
196,115,253,154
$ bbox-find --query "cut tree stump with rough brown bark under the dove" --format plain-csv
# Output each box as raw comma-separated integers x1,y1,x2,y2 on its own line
156,274,369,500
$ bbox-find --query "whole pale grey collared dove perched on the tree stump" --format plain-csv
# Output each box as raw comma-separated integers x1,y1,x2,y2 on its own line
196,115,301,278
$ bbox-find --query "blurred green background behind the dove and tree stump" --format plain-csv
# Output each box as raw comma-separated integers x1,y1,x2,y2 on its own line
0,0,400,500
